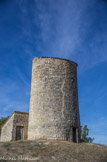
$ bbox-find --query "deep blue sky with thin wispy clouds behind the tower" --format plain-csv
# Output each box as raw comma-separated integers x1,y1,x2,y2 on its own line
0,0,107,144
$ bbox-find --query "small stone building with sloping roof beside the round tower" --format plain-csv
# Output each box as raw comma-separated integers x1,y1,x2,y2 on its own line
1,111,29,142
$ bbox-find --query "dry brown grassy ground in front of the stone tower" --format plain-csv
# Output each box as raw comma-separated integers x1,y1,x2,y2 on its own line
0,140,107,162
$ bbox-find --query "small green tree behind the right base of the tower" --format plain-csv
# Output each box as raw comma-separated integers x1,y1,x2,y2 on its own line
81,125,94,143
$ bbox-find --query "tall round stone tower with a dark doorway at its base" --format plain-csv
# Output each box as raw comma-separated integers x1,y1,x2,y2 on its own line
28,57,80,142
